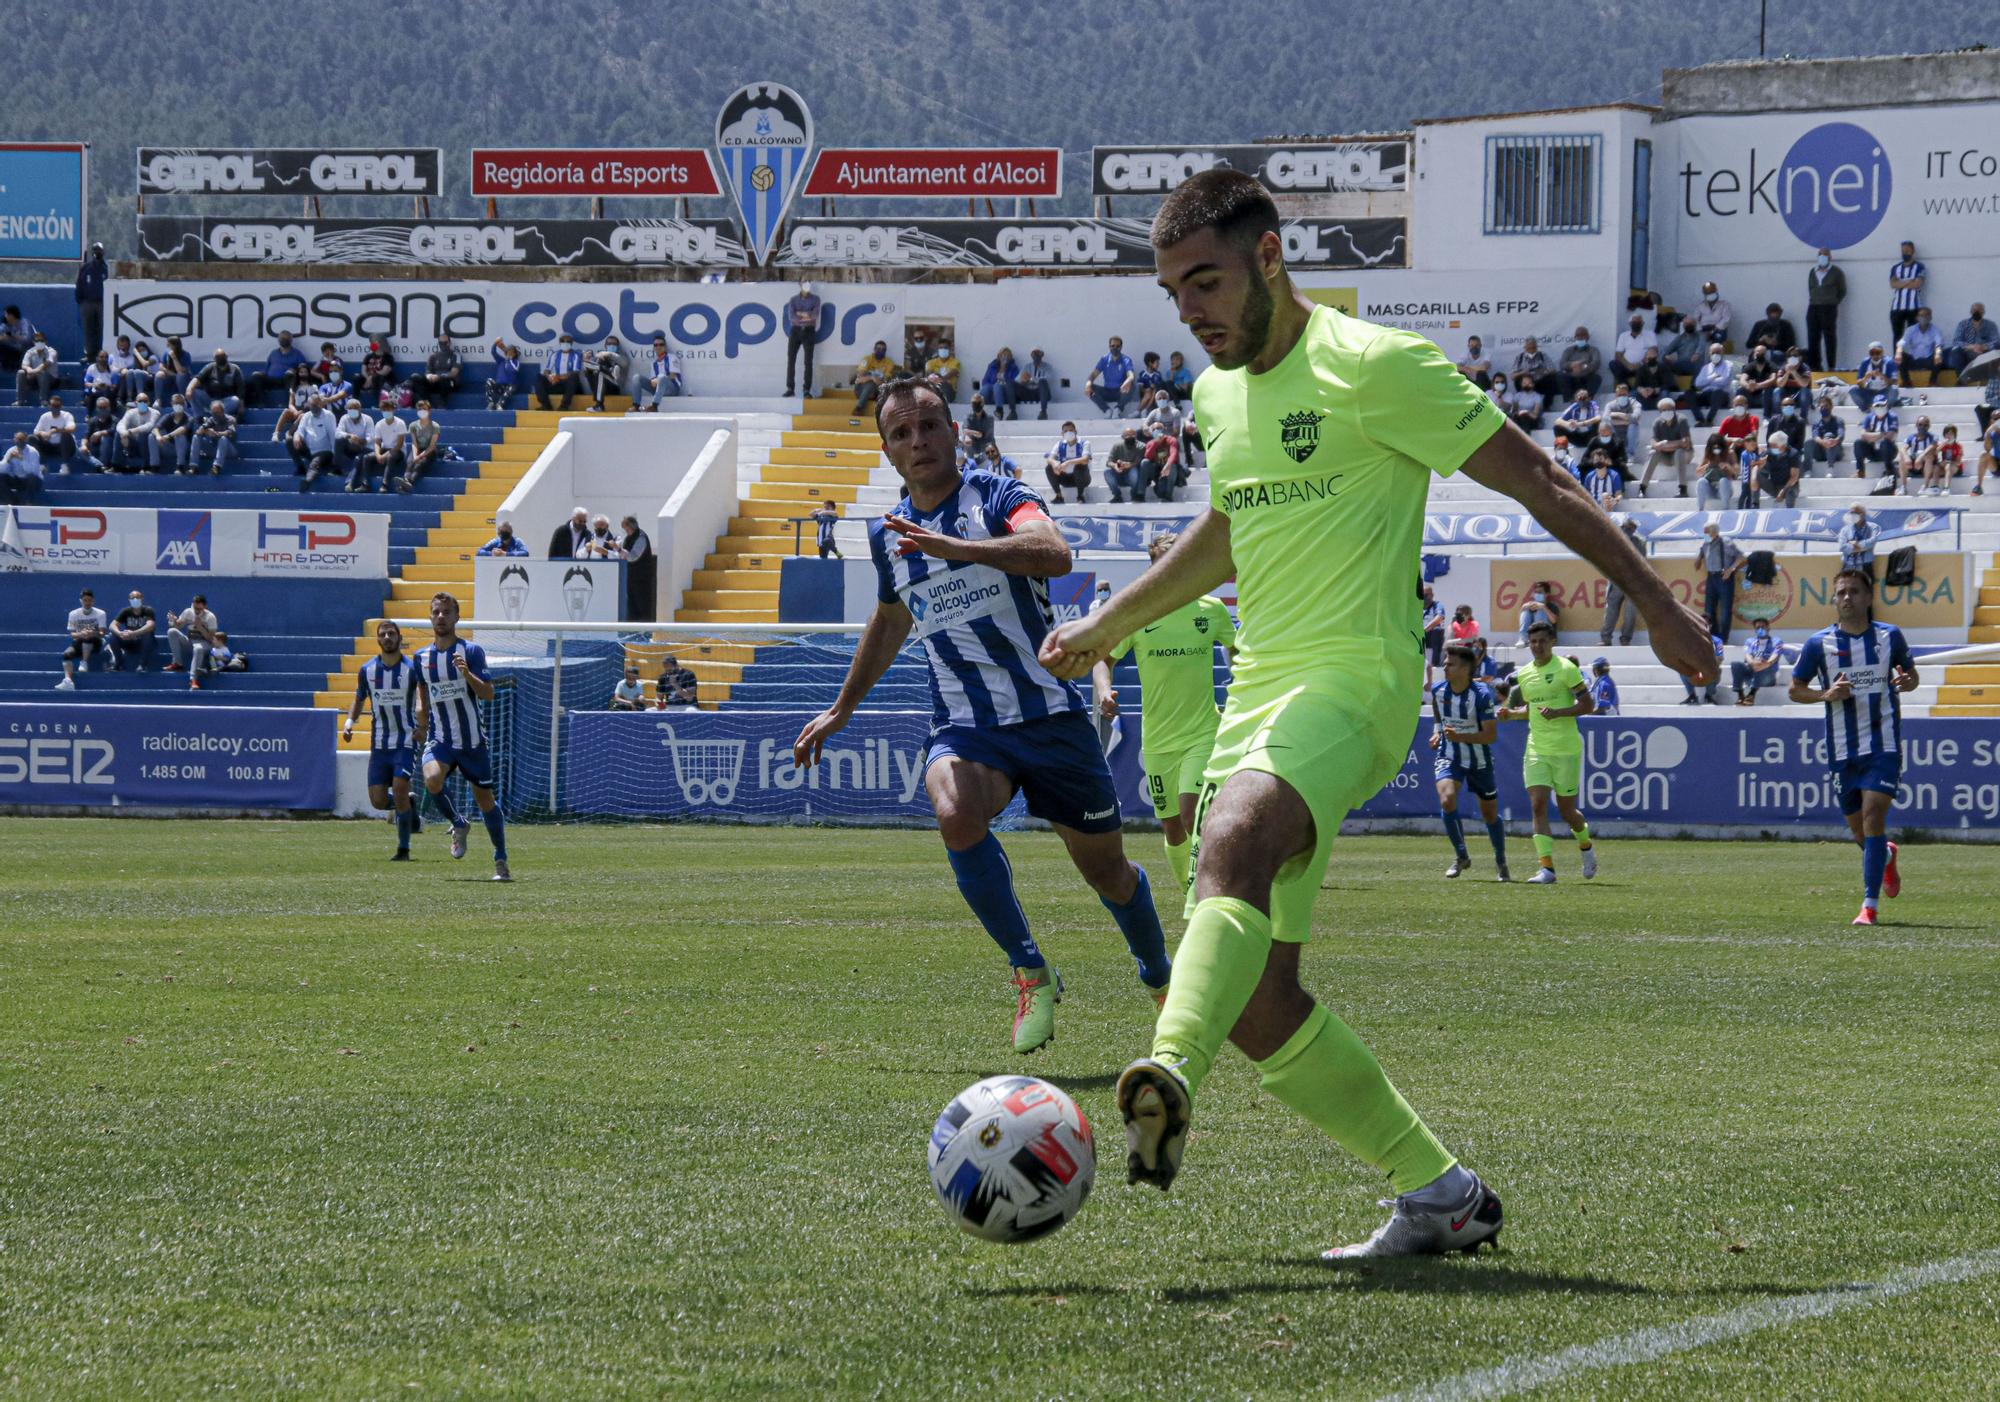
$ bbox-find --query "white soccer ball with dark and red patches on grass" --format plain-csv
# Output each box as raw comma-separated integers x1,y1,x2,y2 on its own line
930,1076,1098,1242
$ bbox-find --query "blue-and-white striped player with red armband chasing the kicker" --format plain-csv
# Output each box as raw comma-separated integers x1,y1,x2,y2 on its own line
792,378,1172,1054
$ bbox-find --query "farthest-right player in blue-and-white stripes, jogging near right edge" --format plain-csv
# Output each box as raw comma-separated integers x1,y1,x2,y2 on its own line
1792,570,1916,924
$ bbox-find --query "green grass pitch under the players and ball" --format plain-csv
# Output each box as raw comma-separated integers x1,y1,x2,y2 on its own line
0,820,2000,1398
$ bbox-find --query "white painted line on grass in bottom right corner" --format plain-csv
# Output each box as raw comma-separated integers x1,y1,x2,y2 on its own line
1384,1246,2000,1402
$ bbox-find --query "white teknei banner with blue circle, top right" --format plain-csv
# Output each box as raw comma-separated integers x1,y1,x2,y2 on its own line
1670,102,2000,262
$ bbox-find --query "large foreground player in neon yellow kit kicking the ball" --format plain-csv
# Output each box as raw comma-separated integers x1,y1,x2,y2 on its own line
1040,170,1716,1256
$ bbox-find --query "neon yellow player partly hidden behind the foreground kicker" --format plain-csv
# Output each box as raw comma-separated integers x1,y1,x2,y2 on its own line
1090,532,1236,900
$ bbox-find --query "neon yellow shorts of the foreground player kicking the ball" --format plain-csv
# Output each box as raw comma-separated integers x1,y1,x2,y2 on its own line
1188,682,1416,944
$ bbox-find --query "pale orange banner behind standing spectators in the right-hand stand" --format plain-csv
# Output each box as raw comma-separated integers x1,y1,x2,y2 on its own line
1488,552,1970,642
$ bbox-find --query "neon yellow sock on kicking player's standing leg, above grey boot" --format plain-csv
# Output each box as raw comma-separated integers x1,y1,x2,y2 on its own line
1256,1008,1458,1192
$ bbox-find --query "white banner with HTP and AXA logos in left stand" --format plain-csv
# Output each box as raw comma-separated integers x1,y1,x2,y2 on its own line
14,506,388,580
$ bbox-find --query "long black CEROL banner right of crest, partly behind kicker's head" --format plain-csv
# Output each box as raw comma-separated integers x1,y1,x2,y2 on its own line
776,218,1410,274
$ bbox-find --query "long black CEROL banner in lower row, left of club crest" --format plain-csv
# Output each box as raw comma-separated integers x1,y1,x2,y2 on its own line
138,214,744,268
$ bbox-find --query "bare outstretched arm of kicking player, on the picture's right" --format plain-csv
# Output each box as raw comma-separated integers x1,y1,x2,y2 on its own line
1464,422,1718,682
